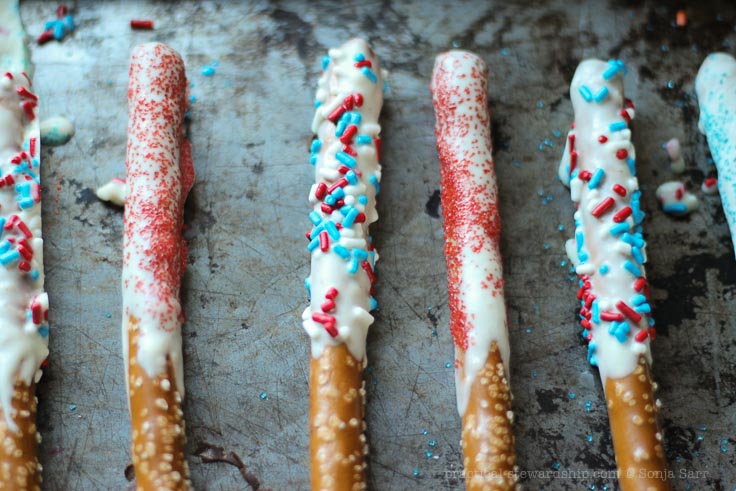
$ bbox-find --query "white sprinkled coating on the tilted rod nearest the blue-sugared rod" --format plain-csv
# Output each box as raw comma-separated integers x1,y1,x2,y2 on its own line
558,60,654,382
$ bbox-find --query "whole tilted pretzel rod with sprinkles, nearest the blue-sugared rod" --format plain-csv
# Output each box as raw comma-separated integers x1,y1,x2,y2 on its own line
559,60,669,491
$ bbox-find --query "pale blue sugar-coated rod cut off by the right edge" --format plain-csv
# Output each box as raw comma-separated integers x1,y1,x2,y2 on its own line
695,53,736,256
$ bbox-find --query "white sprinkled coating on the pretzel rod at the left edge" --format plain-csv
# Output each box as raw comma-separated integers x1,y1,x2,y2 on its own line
0,6,49,430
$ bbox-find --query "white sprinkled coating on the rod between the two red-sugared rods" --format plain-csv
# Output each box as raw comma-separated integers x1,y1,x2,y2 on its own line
302,39,384,360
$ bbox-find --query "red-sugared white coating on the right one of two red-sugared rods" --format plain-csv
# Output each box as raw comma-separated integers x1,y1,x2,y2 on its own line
430,50,510,416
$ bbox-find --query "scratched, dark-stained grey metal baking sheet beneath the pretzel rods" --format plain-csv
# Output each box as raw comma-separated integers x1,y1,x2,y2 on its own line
15,0,736,490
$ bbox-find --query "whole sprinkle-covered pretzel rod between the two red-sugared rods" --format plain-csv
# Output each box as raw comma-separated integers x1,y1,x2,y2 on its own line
302,39,384,490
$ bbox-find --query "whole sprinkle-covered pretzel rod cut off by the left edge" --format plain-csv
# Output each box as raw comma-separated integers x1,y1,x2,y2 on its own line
0,1,49,484
